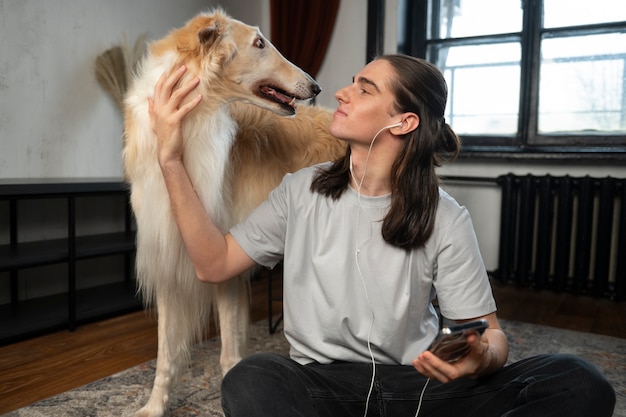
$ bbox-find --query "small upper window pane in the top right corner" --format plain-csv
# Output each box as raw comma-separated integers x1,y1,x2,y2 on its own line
543,0,626,28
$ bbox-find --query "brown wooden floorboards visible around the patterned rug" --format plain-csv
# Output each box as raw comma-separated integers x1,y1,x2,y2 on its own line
0,275,626,415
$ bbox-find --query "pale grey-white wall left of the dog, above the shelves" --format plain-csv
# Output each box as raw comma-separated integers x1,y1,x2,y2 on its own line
0,0,217,178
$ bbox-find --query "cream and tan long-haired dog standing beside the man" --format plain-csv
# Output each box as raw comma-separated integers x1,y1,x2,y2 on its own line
123,9,345,417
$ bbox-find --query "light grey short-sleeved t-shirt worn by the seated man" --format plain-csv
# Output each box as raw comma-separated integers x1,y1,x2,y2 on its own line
231,162,496,365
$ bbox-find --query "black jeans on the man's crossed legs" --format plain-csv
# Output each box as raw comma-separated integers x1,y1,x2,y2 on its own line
222,353,615,417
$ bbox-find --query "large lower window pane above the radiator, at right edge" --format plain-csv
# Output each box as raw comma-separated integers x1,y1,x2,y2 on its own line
538,34,626,134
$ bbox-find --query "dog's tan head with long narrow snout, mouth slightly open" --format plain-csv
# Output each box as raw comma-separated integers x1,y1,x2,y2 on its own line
155,9,321,116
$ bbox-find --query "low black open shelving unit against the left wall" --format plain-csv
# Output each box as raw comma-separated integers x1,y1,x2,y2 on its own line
0,178,142,345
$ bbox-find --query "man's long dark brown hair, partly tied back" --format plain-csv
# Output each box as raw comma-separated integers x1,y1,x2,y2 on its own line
311,54,461,250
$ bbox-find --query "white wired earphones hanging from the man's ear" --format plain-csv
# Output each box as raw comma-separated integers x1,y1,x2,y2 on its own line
350,122,430,417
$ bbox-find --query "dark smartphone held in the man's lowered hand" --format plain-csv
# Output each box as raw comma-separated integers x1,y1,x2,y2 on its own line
428,320,489,363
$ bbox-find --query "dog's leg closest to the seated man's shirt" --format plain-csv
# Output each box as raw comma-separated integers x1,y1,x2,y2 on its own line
216,273,250,374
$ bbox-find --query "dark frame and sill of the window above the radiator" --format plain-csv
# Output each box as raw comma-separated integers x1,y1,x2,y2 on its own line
390,0,626,161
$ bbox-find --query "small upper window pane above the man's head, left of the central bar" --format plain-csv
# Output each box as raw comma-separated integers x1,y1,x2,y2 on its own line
429,0,522,39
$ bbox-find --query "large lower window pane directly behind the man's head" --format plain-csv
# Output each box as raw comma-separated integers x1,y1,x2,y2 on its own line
435,43,521,135
